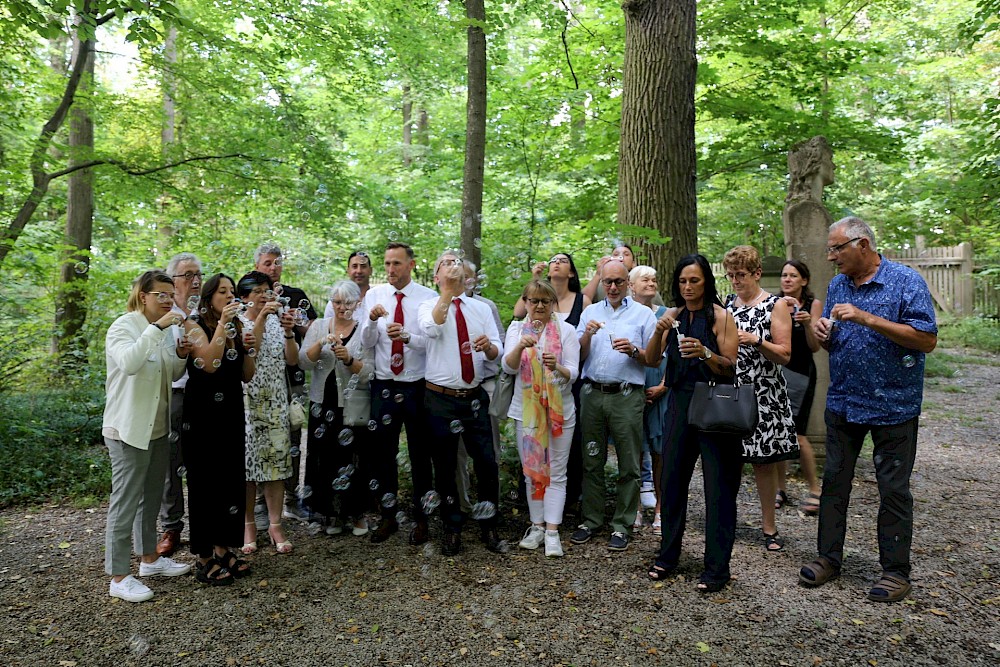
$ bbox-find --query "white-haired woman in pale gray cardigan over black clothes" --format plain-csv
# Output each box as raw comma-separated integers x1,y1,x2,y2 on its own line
299,280,381,537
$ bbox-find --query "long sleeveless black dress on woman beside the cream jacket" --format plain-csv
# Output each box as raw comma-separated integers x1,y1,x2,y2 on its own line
181,323,247,558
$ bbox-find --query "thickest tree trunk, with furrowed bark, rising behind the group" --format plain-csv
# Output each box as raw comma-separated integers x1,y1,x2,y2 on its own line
618,0,698,284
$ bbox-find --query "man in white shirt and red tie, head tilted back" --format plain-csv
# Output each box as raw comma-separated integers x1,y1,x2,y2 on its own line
419,253,505,556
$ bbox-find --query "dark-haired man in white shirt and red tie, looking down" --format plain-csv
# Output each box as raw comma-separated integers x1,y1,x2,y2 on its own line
361,242,437,544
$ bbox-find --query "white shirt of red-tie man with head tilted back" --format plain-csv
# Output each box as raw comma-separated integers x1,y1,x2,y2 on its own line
419,294,503,389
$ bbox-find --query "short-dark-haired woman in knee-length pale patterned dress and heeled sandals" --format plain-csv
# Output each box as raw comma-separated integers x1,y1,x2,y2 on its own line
236,271,299,554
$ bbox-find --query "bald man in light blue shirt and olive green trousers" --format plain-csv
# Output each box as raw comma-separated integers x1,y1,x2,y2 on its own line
570,262,656,551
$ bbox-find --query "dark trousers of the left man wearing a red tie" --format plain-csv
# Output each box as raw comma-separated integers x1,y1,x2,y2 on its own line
371,379,434,521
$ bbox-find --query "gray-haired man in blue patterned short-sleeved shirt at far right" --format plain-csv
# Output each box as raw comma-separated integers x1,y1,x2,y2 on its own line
799,217,937,602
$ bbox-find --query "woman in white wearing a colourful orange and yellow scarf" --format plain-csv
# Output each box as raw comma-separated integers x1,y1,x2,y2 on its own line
503,279,580,558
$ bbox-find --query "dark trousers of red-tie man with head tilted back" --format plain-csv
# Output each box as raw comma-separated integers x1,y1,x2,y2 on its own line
424,388,500,533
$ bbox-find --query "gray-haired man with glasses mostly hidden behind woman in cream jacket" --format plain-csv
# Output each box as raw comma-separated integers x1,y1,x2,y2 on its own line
156,252,201,557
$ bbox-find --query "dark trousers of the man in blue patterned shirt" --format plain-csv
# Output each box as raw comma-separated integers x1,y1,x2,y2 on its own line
817,410,918,579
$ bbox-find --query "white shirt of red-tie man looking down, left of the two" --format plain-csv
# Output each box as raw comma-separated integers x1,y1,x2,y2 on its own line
356,280,437,382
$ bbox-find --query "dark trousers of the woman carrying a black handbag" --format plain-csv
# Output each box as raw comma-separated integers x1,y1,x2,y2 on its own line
656,389,743,582
